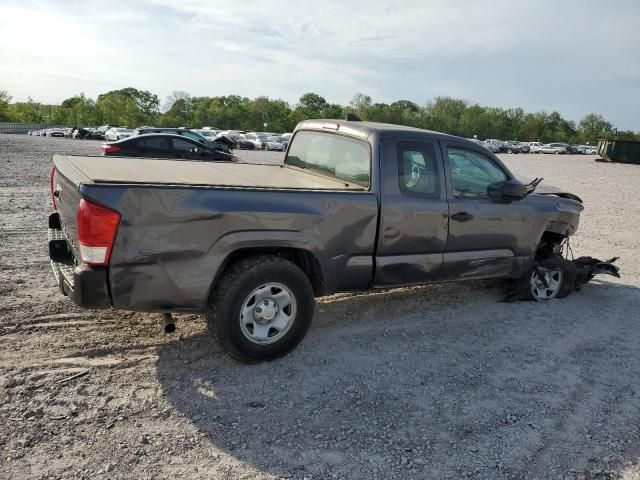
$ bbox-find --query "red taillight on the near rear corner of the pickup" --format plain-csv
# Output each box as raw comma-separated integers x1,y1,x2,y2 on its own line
77,199,120,265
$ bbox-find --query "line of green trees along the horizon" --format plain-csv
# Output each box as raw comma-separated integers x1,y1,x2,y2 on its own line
0,87,640,144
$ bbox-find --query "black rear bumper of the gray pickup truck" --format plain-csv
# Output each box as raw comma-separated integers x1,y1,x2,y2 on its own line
49,212,111,309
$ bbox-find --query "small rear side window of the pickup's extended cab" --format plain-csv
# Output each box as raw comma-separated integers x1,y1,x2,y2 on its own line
398,142,440,198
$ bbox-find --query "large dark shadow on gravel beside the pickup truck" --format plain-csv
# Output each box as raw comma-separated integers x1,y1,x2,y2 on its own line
158,282,640,478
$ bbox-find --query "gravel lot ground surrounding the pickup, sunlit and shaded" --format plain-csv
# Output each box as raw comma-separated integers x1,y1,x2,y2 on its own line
0,135,640,479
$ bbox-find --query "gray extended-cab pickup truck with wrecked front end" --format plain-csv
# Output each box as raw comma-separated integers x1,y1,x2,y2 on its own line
49,120,583,362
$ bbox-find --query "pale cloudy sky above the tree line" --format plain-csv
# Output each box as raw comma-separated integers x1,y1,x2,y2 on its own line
0,0,640,131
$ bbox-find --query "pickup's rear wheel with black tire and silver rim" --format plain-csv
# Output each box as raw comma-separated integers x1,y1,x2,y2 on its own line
207,255,314,363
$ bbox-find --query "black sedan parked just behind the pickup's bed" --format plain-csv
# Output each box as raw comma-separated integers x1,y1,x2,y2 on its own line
102,133,238,161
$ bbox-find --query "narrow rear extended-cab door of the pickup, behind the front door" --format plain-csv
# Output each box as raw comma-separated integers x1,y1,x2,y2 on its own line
374,137,449,286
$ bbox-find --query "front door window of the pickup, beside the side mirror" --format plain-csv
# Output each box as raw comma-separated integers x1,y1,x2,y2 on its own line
447,147,507,198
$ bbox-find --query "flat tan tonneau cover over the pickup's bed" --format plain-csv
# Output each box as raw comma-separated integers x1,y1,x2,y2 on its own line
53,155,364,190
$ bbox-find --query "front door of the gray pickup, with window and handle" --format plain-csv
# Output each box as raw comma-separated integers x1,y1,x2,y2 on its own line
441,139,535,280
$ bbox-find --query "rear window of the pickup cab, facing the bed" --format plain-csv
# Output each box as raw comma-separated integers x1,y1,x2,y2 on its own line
285,131,371,187
